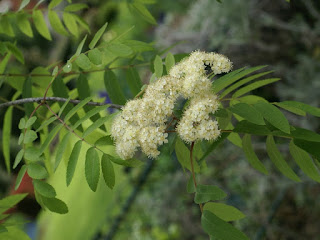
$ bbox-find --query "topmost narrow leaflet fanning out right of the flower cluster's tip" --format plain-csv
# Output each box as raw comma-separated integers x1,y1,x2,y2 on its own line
212,66,266,93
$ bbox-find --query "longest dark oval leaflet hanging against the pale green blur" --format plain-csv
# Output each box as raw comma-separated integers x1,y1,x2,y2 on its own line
85,148,100,192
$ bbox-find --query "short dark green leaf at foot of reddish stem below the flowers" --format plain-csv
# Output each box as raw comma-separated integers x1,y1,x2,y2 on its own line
194,185,227,204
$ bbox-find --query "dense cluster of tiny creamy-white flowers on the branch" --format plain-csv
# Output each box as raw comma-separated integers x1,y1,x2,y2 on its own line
111,51,232,159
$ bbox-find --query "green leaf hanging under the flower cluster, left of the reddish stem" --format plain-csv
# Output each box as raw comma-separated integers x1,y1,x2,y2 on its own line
175,138,200,172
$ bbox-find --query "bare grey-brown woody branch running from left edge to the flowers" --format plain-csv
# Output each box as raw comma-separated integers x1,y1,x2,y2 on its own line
0,97,122,109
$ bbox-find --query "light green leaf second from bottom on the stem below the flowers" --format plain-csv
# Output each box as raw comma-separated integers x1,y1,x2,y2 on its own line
203,202,246,222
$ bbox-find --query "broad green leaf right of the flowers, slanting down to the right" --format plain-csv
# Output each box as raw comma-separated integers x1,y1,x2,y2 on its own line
253,101,290,133
